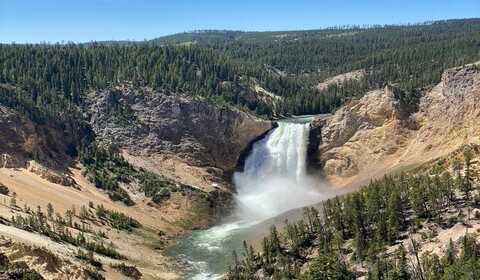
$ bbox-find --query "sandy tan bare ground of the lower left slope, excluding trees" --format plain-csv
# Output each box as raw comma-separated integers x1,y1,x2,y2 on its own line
0,165,188,279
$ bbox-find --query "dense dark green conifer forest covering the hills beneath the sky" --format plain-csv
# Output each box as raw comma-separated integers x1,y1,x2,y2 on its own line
0,19,480,117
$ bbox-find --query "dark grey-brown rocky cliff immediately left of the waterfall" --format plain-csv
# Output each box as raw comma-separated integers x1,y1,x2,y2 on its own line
88,86,273,190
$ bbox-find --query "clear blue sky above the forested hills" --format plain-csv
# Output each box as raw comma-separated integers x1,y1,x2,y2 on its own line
0,0,480,43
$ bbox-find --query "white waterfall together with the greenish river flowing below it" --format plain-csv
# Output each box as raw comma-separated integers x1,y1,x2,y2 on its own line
166,119,323,279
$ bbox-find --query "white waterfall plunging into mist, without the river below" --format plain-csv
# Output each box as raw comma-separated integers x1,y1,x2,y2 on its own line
234,122,321,222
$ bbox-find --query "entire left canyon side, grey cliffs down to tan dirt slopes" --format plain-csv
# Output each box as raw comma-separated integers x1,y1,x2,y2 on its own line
0,86,274,279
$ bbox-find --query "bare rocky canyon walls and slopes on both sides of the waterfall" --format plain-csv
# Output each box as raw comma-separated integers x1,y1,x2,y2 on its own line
0,63,480,279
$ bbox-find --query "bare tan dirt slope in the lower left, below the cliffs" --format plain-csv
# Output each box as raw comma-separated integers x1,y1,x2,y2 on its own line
0,168,181,279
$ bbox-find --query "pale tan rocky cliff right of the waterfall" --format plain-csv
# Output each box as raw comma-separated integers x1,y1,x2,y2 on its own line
312,61,480,185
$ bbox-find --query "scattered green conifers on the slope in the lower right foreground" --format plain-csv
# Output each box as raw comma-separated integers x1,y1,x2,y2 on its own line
228,146,480,280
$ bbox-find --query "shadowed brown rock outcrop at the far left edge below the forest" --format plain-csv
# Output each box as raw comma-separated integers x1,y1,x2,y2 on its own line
0,105,80,186
